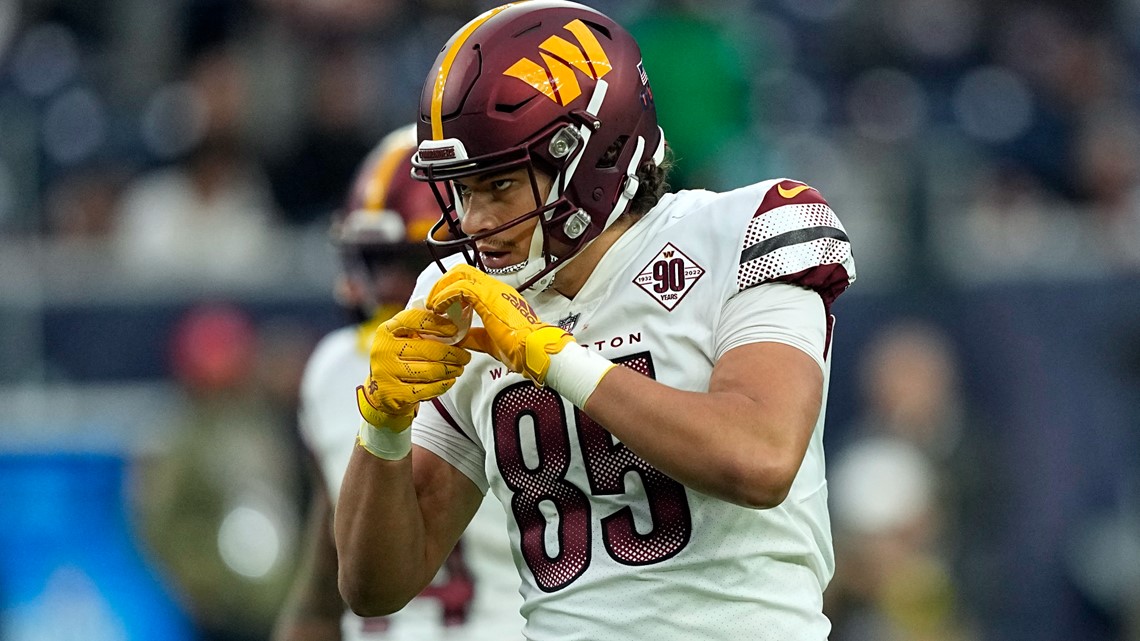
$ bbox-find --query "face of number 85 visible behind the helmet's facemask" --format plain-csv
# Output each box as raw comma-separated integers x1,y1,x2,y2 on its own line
455,169,551,269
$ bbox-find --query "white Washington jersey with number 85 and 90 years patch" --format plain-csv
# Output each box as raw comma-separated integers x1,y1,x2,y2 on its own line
413,180,855,641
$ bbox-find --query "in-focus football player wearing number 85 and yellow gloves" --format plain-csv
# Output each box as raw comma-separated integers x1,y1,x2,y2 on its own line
336,0,855,641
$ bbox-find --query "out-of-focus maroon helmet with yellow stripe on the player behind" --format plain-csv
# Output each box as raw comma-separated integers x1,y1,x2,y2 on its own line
331,124,439,321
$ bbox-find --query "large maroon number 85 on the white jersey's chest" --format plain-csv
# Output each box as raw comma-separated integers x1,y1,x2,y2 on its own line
491,352,692,592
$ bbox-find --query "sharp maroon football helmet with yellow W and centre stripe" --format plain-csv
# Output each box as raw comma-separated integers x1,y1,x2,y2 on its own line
412,0,665,290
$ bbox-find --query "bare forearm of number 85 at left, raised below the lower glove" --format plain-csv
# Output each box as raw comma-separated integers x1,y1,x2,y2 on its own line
335,446,435,616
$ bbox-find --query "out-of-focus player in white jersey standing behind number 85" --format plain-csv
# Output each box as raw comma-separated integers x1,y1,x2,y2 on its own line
274,127,523,641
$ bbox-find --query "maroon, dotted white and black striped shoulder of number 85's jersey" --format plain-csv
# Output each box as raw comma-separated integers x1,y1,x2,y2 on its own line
736,179,855,310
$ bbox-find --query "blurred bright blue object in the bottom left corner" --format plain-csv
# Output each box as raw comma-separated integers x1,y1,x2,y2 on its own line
0,452,193,641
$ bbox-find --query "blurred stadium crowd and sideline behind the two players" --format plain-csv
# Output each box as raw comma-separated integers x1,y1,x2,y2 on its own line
0,0,1140,641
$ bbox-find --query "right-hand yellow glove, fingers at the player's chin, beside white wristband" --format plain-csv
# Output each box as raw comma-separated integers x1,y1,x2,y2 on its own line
426,265,573,386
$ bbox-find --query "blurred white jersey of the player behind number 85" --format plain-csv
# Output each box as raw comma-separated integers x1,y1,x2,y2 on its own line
300,321,523,641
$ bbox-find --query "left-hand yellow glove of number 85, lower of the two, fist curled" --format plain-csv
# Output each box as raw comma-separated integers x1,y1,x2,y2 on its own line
357,309,471,432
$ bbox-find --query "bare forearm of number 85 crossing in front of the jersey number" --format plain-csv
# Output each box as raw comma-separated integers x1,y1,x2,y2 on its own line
585,367,816,508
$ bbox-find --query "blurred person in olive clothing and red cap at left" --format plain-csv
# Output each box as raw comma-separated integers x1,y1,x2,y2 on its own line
133,302,311,641
